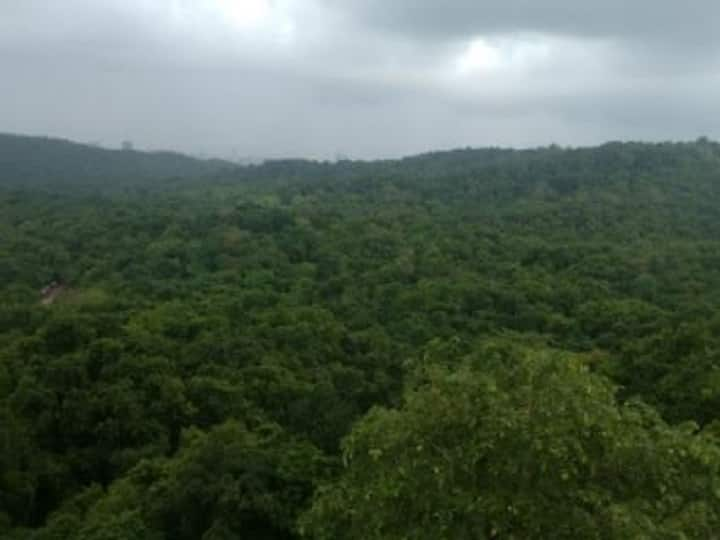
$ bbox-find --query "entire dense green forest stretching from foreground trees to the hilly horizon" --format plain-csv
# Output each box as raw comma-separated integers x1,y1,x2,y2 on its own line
0,138,720,540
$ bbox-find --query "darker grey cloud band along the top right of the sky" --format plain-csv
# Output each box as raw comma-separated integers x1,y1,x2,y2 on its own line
324,0,720,48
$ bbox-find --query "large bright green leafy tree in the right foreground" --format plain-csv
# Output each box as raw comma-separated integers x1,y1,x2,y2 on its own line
302,349,720,540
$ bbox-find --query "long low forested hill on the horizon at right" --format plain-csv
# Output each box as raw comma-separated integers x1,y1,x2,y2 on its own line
226,137,720,199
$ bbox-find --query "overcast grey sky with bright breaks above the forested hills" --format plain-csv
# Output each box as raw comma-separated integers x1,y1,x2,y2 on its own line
0,0,720,158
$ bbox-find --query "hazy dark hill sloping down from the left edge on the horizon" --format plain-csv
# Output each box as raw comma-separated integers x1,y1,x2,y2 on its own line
0,134,234,189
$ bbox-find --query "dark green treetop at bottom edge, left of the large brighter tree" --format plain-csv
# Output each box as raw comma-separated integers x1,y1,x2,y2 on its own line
73,421,325,540
